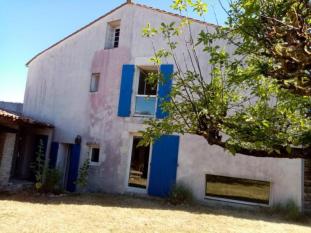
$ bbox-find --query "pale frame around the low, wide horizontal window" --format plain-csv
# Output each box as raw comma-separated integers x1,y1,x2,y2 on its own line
204,174,272,207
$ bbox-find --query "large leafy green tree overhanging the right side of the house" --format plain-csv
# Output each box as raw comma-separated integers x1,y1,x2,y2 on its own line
141,0,311,158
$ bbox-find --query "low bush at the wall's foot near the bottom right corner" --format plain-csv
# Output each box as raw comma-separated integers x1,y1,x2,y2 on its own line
272,200,302,221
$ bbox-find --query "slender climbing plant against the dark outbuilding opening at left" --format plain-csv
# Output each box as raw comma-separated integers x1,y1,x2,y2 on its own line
31,139,45,191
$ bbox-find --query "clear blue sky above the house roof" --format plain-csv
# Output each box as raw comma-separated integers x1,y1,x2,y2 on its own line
0,0,226,102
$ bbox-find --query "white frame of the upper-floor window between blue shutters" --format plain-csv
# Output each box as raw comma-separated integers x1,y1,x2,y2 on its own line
132,66,159,118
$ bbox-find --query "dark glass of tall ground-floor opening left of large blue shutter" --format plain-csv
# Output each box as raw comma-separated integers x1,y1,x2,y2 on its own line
128,137,150,189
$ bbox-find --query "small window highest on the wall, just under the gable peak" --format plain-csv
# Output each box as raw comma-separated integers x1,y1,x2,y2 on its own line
105,20,121,49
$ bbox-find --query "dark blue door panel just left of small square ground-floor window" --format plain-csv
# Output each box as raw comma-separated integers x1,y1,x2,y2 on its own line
66,144,81,192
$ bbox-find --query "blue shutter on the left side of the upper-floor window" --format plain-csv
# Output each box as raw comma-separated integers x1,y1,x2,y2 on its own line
118,65,135,117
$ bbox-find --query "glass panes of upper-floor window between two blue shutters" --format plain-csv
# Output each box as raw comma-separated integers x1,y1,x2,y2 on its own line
135,69,157,116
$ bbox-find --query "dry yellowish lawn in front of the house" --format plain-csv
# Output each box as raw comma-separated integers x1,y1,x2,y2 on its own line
0,194,311,233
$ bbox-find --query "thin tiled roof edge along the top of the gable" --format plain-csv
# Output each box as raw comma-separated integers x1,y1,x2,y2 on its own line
26,2,217,66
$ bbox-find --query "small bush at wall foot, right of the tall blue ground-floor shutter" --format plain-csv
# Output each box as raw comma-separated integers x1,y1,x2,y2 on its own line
168,184,193,205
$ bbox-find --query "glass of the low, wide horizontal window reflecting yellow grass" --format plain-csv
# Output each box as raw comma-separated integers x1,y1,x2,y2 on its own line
205,175,270,205
